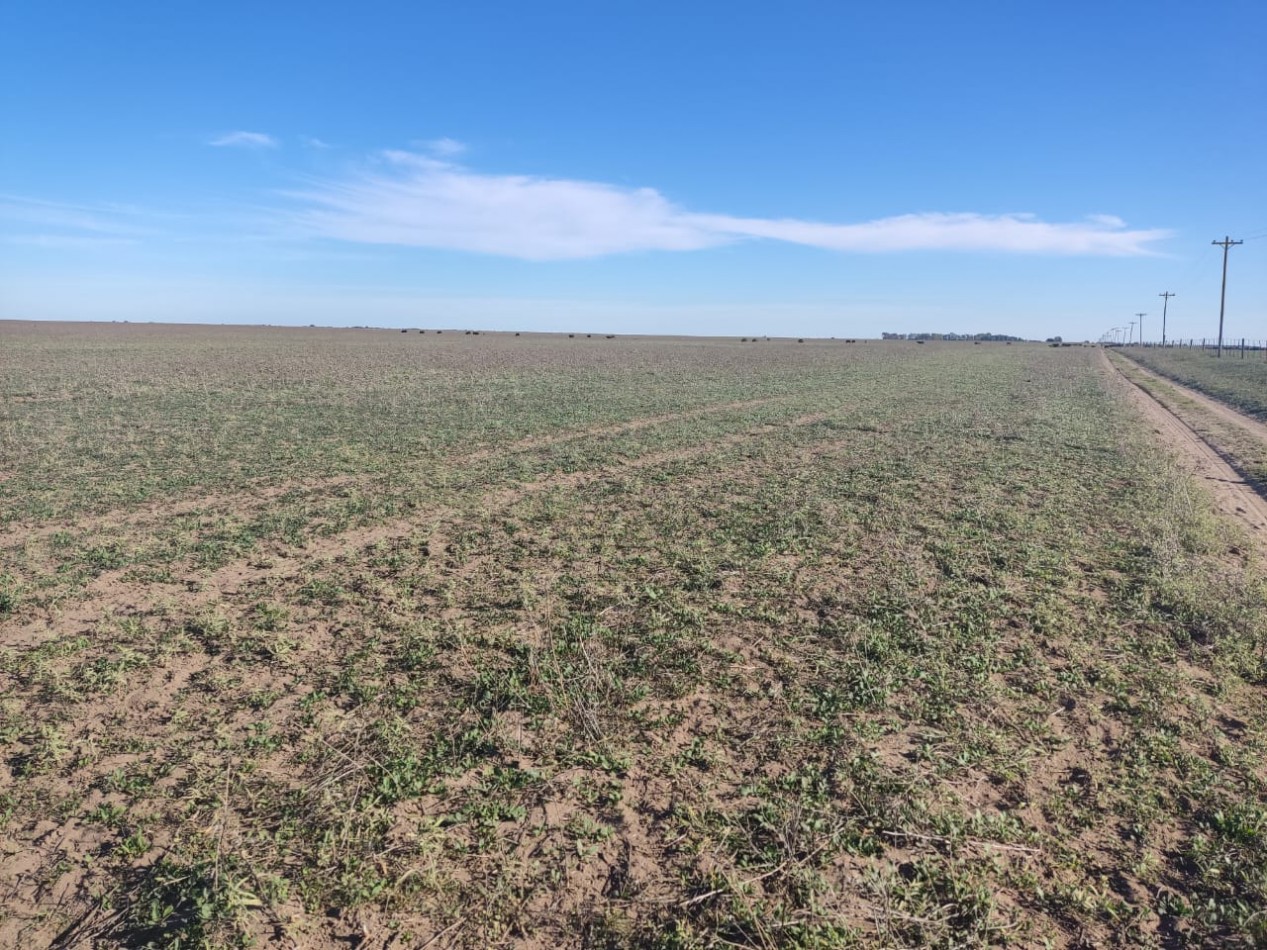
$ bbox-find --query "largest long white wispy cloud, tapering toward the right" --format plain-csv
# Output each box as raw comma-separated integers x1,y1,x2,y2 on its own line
288,153,1169,261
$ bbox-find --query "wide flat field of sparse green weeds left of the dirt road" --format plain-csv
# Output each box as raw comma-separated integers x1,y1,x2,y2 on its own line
0,324,1267,947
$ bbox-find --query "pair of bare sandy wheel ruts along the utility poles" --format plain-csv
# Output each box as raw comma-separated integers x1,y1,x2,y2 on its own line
1100,350,1267,559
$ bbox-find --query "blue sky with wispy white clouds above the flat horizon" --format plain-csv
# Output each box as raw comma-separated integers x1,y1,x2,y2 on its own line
0,0,1267,338
